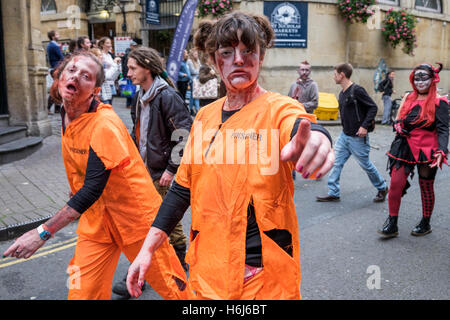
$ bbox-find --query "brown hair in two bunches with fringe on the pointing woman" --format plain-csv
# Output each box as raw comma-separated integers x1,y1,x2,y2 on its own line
194,12,275,61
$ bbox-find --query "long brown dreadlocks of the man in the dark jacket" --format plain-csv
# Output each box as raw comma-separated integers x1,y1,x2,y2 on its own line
128,47,176,88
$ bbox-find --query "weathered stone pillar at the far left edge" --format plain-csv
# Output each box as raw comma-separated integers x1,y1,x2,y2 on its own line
0,0,51,136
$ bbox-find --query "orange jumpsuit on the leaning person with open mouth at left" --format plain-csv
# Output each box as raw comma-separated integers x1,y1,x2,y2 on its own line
62,104,186,300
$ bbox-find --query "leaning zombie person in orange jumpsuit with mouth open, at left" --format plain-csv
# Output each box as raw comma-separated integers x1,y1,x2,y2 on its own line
4,53,186,300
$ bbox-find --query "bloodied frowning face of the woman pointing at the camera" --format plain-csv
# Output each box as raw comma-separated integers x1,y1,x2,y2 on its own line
214,30,264,91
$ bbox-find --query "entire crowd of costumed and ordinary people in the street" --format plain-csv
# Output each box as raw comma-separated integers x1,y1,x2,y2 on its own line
3,12,449,300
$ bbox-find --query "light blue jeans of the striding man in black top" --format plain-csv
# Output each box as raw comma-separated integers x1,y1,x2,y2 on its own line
328,132,387,197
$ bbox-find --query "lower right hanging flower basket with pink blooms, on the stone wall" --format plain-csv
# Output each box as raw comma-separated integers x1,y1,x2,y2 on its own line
381,9,417,56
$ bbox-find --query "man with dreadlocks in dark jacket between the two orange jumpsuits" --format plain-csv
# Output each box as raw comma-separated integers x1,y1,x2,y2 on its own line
113,47,192,296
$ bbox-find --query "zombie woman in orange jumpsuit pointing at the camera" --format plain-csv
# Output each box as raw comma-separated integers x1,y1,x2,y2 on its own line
127,12,334,299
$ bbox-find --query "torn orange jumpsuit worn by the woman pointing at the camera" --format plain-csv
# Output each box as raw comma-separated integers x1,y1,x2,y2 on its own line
176,92,316,299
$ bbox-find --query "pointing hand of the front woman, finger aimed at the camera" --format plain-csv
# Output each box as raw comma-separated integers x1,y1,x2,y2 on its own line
280,121,334,179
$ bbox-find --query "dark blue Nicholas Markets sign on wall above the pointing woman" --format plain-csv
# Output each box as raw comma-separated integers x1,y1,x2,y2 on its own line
264,1,308,48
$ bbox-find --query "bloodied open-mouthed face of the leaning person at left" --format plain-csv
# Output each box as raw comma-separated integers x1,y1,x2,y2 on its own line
58,56,99,104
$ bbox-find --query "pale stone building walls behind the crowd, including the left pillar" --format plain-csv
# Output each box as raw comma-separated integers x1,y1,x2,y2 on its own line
0,0,450,136
